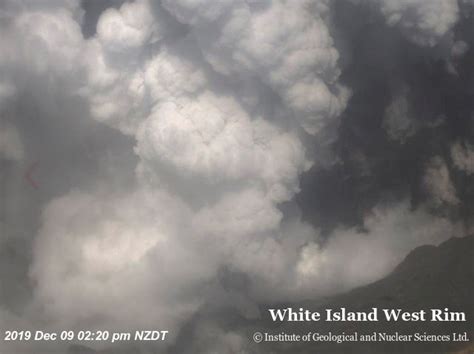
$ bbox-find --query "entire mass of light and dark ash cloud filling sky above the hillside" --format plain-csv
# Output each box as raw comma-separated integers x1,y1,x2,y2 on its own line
0,0,473,352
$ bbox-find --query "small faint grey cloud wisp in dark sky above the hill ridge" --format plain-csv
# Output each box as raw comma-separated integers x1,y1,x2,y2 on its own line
423,156,459,206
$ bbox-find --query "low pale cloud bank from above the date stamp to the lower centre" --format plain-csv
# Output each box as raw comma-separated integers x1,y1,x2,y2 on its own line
31,188,313,344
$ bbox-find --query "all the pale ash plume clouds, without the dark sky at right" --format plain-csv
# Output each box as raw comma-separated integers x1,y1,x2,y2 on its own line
0,0,470,352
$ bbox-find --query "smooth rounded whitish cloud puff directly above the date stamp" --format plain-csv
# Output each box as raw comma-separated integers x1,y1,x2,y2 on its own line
31,190,215,338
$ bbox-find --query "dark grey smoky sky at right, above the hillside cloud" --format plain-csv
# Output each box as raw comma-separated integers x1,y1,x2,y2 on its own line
297,1,473,235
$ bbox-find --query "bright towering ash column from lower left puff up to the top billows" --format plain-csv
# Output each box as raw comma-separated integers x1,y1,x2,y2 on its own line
27,2,342,342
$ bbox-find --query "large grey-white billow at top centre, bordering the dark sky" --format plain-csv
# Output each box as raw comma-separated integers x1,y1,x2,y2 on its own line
164,0,348,134
